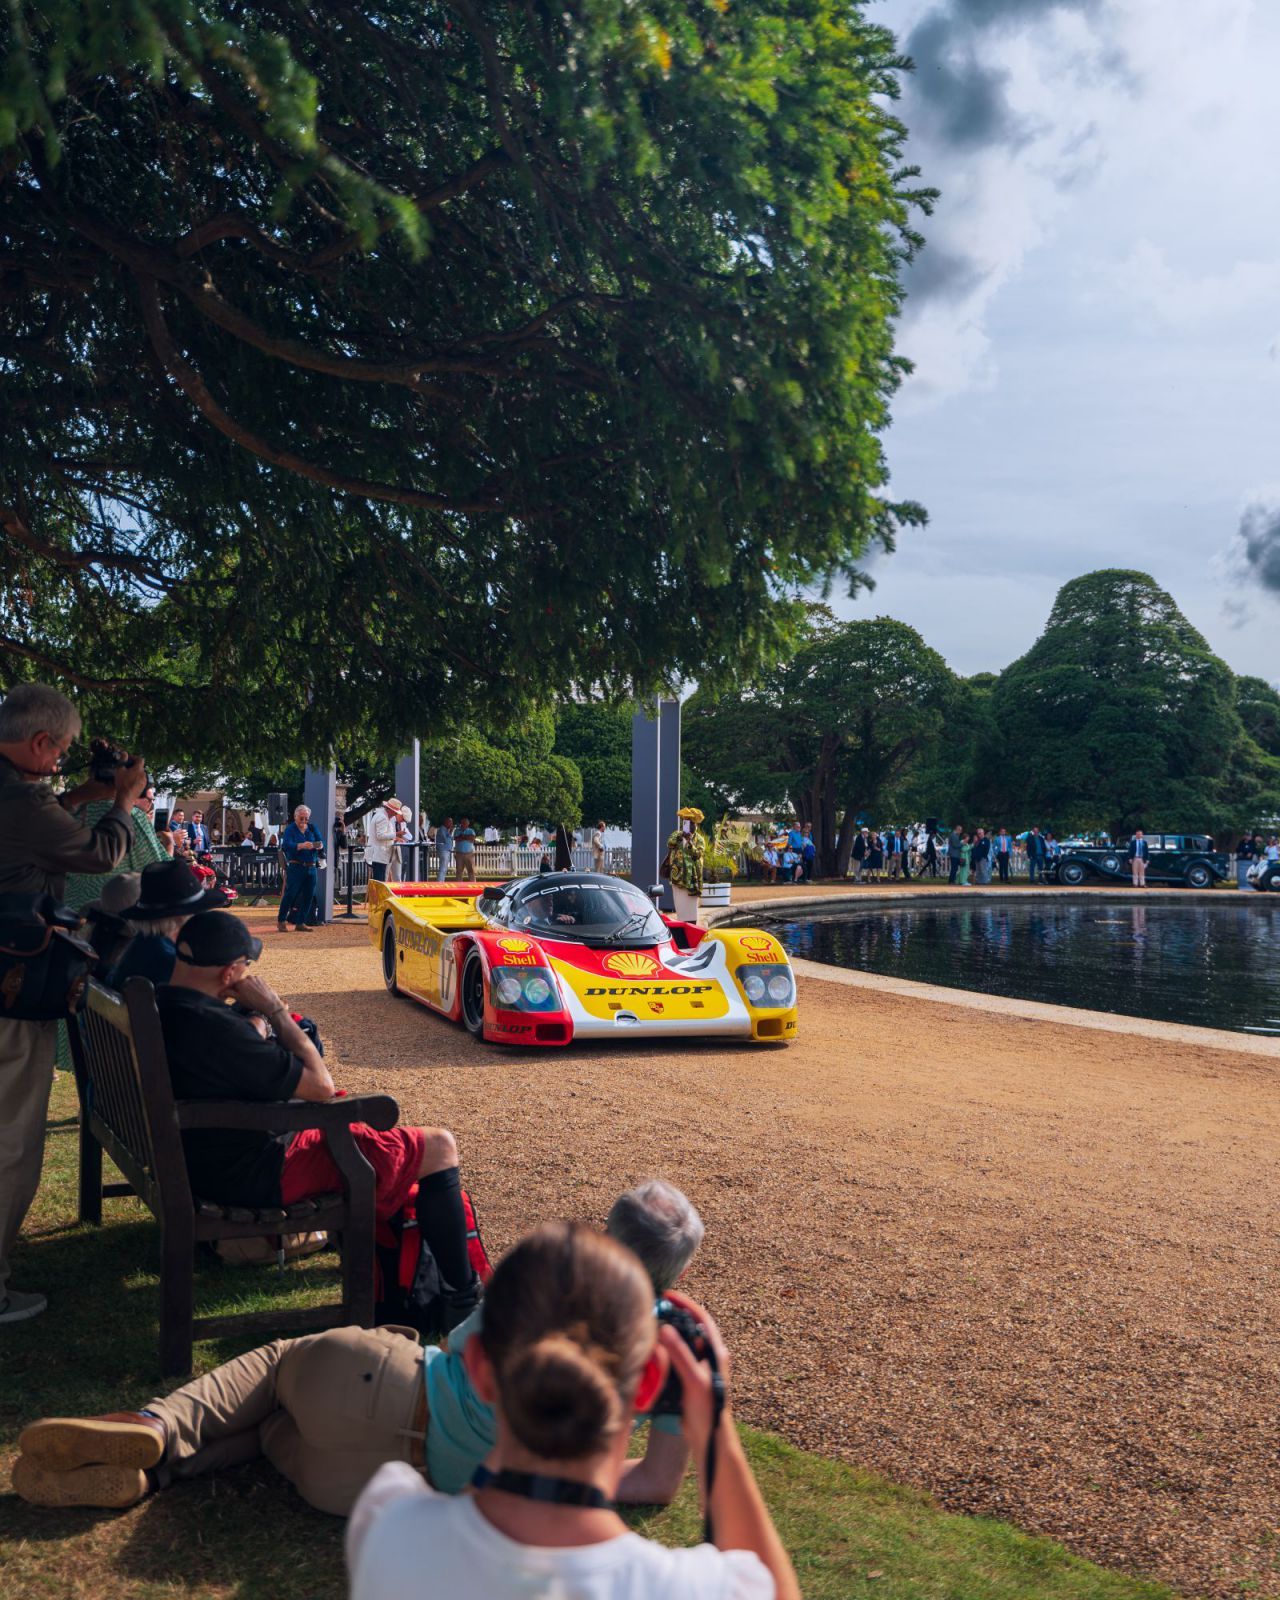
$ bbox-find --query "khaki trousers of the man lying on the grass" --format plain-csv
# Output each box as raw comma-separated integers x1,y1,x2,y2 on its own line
147,1328,426,1517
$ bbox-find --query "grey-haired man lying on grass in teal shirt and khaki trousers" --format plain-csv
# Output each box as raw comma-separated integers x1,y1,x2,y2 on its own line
13,1179,702,1517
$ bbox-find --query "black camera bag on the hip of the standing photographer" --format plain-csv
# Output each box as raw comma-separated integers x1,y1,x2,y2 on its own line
0,894,98,1022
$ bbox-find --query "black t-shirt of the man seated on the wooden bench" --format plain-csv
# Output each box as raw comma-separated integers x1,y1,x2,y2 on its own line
155,986,302,1208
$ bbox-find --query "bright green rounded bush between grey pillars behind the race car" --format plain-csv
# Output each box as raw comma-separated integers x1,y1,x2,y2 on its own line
422,710,582,827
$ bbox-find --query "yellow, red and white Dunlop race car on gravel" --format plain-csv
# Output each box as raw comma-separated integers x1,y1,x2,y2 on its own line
368,872,795,1045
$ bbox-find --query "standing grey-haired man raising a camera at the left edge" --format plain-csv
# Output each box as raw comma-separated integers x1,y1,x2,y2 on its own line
0,683,147,1323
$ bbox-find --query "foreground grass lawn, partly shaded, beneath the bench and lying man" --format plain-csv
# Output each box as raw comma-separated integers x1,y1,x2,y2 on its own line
0,1078,1173,1600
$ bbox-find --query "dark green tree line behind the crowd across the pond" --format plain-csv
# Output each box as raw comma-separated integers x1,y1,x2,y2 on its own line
685,570,1280,874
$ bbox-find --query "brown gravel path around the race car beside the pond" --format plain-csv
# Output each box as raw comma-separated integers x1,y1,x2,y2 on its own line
250,914,1280,1597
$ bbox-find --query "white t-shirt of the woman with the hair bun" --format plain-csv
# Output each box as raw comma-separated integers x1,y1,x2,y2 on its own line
347,1461,776,1600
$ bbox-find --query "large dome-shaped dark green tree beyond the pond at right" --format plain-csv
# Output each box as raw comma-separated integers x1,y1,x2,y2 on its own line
992,570,1280,835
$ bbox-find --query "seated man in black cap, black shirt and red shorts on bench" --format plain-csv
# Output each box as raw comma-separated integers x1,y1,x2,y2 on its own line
155,910,477,1314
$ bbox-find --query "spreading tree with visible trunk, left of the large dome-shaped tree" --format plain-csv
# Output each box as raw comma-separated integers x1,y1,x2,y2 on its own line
683,618,958,875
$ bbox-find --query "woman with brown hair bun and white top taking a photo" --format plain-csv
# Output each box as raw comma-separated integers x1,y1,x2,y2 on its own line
347,1222,800,1600
